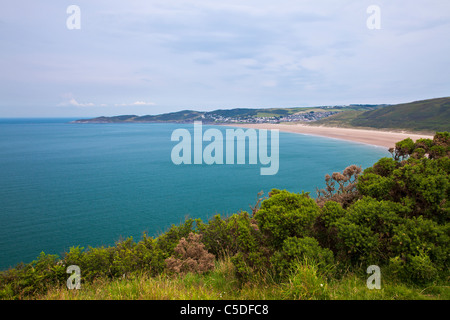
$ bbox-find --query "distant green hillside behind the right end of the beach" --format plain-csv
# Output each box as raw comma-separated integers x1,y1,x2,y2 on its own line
315,97,450,132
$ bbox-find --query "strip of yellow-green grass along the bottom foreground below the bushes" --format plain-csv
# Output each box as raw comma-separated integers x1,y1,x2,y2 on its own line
34,259,450,300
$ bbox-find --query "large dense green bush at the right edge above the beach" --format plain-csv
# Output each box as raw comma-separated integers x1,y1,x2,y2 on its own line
321,133,450,283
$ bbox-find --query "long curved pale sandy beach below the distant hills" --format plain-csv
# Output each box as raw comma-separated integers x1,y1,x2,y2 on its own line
223,123,433,148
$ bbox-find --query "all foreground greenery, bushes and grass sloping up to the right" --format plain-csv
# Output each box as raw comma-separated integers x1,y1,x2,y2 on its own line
0,132,450,300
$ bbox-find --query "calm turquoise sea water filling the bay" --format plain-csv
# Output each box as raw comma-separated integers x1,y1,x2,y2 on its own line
0,119,389,269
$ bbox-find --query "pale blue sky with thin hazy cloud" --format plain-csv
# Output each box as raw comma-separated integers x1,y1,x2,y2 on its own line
0,0,450,117
